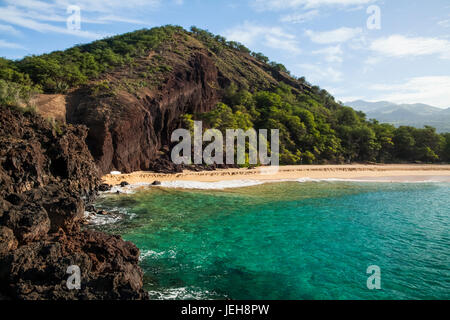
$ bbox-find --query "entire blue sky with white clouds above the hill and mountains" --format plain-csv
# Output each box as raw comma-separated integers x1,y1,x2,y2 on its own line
0,0,450,108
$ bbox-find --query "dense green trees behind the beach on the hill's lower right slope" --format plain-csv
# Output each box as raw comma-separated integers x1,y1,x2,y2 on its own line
184,84,450,164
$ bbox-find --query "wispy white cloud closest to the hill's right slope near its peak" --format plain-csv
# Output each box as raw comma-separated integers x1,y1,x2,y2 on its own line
224,22,301,54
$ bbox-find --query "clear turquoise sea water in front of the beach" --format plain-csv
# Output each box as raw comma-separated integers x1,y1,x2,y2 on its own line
93,182,450,300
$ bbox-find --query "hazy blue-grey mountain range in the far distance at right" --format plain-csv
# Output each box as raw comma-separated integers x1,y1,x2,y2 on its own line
345,100,450,132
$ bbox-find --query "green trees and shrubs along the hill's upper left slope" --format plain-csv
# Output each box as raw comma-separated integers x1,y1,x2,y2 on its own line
0,26,182,93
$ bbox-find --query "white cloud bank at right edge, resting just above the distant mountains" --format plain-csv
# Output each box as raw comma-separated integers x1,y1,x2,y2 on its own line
370,76,450,108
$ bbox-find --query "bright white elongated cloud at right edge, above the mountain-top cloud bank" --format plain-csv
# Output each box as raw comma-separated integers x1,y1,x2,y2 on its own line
370,35,450,59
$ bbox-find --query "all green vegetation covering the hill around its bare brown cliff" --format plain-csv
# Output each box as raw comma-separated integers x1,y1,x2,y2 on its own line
0,26,450,164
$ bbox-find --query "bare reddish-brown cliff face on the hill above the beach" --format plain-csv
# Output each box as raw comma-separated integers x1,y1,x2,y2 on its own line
67,52,219,173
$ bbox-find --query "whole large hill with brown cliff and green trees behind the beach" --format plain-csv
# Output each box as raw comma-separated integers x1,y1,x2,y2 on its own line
0,26,450,173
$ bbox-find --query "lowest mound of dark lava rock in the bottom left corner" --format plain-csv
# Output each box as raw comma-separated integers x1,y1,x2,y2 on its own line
0,231,145,300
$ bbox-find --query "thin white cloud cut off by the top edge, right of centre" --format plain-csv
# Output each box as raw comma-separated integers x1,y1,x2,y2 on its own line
253,0,376,10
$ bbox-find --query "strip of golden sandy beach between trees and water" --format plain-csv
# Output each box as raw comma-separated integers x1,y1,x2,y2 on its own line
103,164,450,185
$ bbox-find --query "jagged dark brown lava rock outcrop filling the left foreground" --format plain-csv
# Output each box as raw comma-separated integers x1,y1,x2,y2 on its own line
0,108,146,299
